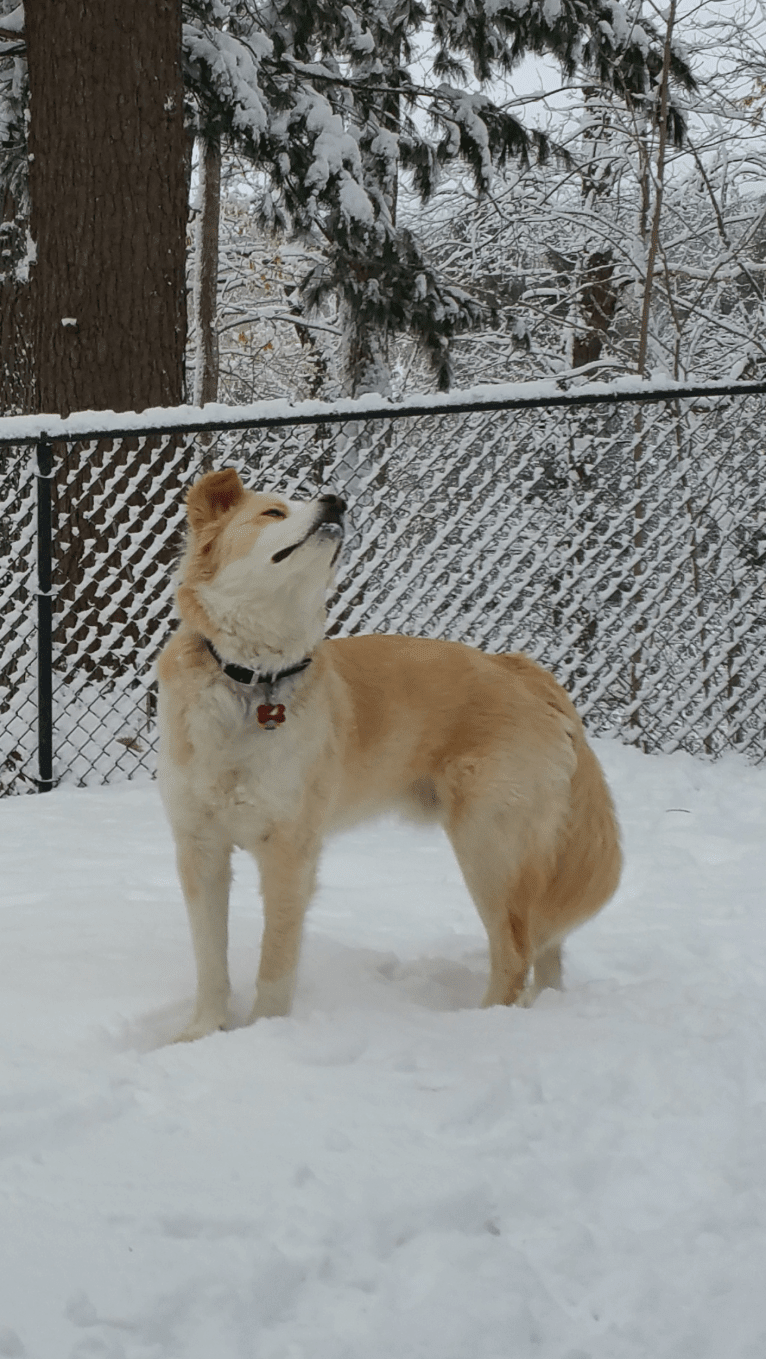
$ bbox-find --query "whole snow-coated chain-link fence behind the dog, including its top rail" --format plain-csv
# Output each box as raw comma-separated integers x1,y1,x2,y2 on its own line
0,379,766,792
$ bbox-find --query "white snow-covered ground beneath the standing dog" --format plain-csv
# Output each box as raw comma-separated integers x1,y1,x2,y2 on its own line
0,742,766,1359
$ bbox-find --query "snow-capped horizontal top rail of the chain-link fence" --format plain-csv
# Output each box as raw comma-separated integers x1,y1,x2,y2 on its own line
0,376,766,447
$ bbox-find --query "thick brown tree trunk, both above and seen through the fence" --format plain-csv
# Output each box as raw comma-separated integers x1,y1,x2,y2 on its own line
22,0,187,690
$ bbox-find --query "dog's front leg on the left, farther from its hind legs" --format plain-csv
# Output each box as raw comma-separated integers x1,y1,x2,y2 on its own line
175,834,231,1042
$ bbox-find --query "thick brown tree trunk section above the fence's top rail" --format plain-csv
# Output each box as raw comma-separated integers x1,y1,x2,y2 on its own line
26,0,186,414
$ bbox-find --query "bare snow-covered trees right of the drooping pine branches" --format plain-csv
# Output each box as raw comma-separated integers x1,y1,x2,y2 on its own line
421,0,766,394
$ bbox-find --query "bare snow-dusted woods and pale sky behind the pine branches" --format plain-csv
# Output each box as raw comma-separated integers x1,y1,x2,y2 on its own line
190,4,766,401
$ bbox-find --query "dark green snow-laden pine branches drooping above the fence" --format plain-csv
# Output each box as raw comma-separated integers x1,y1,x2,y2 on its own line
186,0,694,391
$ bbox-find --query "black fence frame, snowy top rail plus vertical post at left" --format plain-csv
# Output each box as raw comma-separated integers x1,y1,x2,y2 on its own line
0,379,766,792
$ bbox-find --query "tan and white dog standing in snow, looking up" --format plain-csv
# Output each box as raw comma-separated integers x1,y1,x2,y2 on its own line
158,469,621,1040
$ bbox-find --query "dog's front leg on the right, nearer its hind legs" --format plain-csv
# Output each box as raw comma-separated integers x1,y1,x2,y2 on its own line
250,829,319,1023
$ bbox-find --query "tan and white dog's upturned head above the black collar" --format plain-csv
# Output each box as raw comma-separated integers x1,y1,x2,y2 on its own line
178,467,345,665
